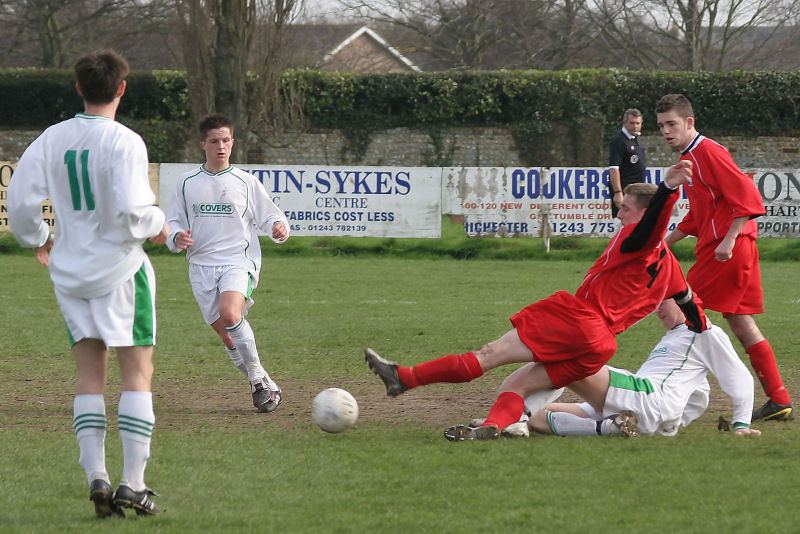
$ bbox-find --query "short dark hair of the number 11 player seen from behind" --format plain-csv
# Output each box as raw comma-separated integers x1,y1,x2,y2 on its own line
72,50,131,104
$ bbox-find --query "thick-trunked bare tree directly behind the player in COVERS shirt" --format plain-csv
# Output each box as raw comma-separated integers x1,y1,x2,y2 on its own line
175,0,302,161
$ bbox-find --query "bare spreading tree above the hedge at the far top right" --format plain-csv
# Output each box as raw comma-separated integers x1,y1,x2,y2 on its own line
592,0,798,71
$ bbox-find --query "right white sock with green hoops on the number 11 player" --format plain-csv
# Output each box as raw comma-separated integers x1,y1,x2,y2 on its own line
118,391,156,491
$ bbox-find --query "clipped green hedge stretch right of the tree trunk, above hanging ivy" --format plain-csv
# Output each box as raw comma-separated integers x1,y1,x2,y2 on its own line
287,69,800,135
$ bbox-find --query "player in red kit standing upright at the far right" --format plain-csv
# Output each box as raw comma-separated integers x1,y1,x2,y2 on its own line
656,94,793,421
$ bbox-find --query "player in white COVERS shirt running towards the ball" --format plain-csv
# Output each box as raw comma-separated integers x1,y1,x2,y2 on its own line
167,114,289,412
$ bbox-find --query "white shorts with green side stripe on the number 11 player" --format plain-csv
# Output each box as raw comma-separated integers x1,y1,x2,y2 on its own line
55,257,156,347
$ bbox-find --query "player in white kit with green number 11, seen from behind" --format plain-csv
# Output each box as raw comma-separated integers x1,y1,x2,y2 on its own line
8,51,168,517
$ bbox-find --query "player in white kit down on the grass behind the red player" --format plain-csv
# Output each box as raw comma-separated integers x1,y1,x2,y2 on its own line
528,299,761,436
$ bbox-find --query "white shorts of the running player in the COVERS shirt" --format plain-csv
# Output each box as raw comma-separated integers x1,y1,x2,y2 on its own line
189,263,256,324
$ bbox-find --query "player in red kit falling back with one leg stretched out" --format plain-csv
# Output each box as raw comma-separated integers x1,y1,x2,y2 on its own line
365,162,706,441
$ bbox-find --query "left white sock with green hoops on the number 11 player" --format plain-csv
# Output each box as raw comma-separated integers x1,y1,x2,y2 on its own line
72,395,111,484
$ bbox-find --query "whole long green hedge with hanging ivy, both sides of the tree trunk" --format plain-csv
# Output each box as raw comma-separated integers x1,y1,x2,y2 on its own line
0,69,800,161
